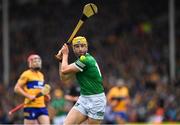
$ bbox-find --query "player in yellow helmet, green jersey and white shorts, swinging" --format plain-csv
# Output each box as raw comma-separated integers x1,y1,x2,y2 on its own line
57,36,106,125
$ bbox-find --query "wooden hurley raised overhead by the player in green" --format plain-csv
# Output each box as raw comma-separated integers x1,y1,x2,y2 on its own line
55,3,98,60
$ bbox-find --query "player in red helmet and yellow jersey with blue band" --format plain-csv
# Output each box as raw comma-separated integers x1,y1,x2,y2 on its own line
14,54,50,124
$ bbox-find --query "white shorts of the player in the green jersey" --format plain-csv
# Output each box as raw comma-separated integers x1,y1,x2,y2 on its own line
73,93,107,120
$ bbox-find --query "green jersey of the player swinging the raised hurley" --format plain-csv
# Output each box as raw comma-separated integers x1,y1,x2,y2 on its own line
74,53,104,95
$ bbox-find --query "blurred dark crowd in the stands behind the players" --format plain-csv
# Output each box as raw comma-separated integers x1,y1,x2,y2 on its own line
0,0,180,124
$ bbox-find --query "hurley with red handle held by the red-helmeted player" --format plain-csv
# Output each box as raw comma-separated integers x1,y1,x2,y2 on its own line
9,84,51,115
